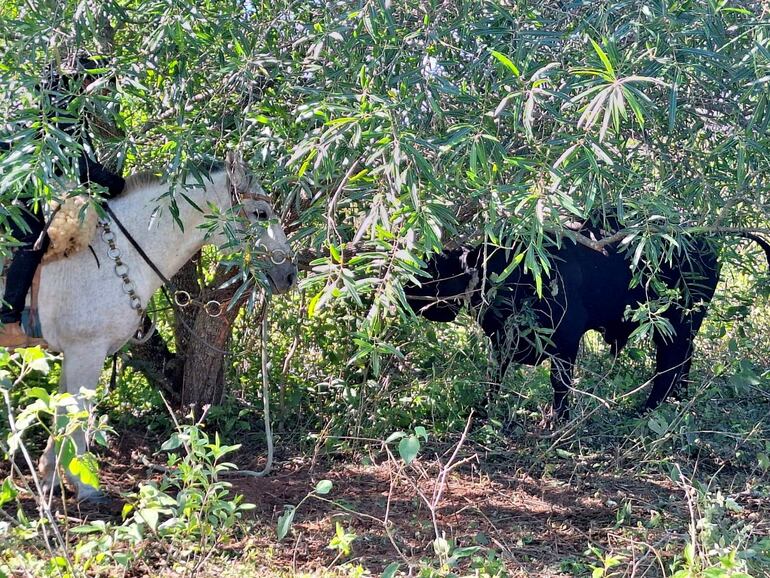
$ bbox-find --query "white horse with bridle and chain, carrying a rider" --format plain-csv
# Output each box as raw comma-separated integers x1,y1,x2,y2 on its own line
31,157,297,500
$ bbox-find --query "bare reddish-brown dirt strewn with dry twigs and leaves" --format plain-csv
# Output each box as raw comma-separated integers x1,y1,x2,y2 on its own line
3,420,770,577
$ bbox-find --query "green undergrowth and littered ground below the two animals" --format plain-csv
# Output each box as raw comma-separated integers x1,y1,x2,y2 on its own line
0,268,770,578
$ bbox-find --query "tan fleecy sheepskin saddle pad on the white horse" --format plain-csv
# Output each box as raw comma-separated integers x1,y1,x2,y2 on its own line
43,195,98,263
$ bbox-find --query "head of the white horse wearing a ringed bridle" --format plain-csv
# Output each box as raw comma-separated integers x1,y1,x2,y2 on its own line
225,153,297,293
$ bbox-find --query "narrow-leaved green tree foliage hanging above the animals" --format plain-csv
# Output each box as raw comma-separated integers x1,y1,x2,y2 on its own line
0,0,770,404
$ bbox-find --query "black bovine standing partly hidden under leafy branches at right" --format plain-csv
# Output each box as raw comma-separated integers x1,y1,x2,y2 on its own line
404,227,770,418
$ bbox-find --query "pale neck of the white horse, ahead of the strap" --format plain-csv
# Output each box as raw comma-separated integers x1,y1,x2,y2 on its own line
110,173,227,278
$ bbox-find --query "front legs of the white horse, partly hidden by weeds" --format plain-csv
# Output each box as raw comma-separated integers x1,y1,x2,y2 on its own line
40,345,106,501
